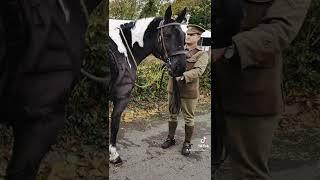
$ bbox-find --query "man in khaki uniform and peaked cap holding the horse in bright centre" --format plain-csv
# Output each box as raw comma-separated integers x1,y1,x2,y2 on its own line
161,24,209,155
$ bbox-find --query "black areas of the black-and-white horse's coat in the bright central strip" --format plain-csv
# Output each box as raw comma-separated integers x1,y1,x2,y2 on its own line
109,14,185,149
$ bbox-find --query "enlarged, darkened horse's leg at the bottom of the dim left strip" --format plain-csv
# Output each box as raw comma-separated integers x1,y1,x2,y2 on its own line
7,108,65,180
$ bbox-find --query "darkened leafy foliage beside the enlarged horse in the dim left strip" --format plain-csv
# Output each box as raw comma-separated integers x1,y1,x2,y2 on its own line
60,2,108,146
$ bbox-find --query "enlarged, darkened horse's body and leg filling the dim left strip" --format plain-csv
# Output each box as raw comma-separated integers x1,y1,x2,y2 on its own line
0,0,102,180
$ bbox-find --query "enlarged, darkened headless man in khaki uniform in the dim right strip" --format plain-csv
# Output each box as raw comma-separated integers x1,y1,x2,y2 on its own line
213,0,310,180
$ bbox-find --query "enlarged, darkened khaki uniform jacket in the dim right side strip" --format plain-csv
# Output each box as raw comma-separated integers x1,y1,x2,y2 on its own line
216,0,310,115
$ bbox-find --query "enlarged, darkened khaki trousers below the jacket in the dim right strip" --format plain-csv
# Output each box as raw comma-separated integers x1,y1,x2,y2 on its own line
224,114,279,180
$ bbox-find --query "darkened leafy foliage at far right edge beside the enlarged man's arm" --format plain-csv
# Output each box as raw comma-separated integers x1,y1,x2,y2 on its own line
284,0,320,96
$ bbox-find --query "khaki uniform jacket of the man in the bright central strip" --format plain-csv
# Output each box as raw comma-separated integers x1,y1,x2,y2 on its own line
167,48,209,99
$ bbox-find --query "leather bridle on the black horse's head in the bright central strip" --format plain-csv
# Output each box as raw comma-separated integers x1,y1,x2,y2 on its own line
157,20,186,64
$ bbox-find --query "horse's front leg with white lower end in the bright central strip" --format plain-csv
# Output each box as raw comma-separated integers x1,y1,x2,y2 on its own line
109,97,129,164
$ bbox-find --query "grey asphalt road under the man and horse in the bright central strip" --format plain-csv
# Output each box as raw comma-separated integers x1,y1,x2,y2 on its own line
109,113,211,180
